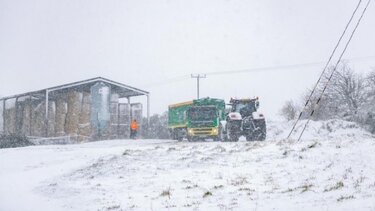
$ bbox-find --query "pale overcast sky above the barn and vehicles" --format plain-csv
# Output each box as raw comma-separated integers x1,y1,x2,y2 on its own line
0,0,375,118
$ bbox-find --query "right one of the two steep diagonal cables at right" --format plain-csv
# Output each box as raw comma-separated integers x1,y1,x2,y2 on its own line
297,0,371,142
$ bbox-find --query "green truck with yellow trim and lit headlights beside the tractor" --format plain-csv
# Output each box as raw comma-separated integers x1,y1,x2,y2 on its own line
168,98,225,141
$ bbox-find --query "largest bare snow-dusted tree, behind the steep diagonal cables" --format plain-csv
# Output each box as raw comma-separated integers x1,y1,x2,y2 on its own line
294,63,367,121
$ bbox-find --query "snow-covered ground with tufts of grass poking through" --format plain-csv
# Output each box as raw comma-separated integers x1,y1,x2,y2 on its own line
0,120,375,211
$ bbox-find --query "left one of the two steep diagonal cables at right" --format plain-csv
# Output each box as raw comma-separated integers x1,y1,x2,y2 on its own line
287,0,362,139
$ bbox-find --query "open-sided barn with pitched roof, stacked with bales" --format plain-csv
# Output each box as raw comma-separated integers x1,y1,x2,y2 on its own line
0,77,150,141
